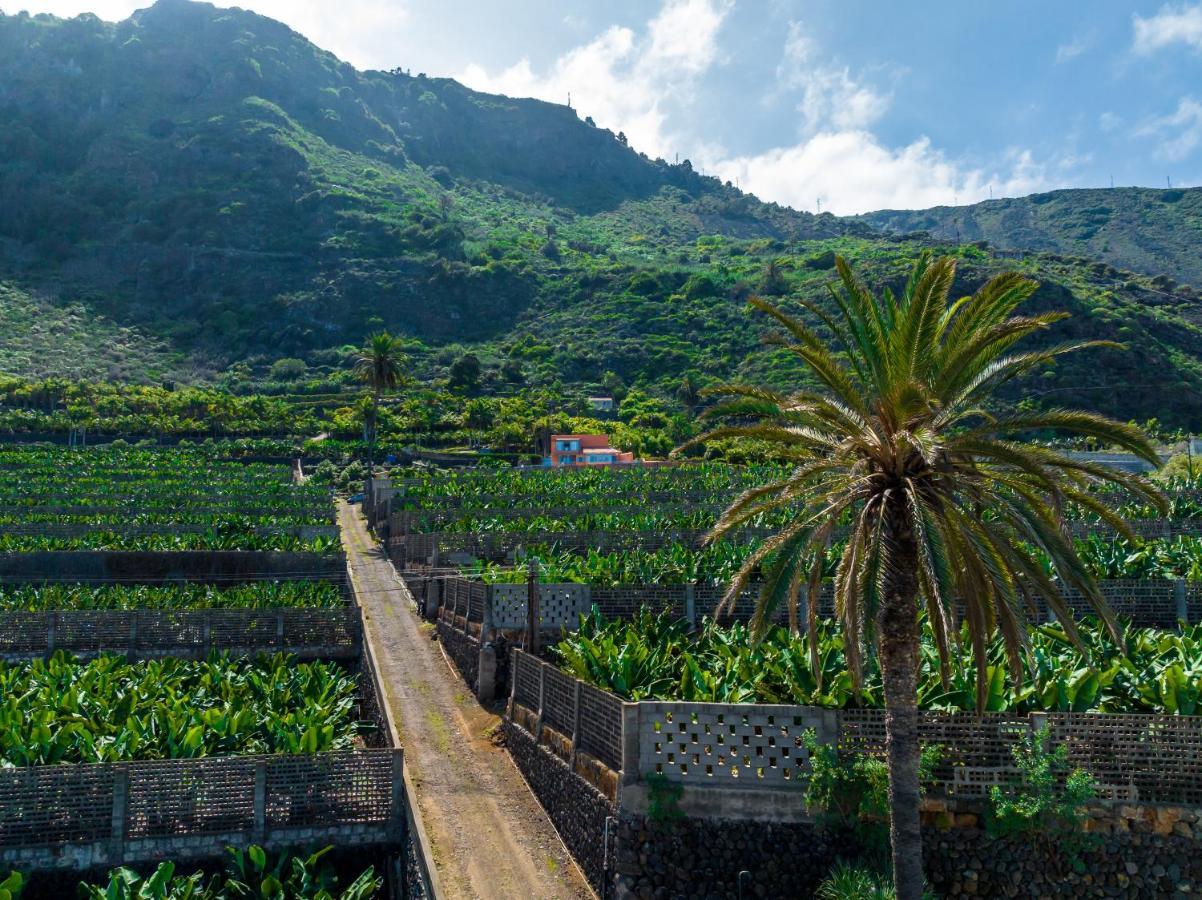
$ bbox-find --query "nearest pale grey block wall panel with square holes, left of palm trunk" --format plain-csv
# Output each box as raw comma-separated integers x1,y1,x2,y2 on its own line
638,703,835,788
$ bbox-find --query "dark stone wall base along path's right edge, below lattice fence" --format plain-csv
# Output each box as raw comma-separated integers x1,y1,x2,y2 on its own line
502,717,614,896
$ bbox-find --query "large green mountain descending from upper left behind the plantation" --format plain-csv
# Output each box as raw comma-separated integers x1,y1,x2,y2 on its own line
0,0,1202,424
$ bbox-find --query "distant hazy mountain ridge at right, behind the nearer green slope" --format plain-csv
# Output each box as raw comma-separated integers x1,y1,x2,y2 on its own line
858,187,1202,287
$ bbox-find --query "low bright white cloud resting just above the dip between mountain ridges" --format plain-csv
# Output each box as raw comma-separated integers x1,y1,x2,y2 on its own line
706,130,1046,215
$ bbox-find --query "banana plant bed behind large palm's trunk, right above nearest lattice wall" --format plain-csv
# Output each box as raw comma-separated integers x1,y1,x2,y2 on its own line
553,610,1202,715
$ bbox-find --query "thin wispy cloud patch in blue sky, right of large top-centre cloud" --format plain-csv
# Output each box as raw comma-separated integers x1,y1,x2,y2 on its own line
769,22,889,133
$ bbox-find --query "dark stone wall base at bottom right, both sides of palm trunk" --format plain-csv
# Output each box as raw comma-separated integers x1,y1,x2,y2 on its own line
613,813,1202,900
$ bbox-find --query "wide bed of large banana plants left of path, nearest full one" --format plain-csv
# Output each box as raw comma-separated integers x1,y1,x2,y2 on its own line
0,652,359,767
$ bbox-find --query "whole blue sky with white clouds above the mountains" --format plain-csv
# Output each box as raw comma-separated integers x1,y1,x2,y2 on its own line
7,0,1202,214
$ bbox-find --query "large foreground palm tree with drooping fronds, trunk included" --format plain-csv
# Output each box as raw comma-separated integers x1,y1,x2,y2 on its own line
690,256,1164,900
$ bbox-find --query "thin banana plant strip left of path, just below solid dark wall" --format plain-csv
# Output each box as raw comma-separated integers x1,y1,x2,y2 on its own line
0,580,344,612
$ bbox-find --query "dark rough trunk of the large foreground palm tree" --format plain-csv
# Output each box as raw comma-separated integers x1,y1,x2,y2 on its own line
876,511,926,900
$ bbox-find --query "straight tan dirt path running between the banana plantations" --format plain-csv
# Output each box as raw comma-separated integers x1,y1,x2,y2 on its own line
338,503,594,900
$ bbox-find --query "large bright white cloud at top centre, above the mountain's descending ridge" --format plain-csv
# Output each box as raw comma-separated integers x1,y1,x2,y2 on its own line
459,0,730,156
